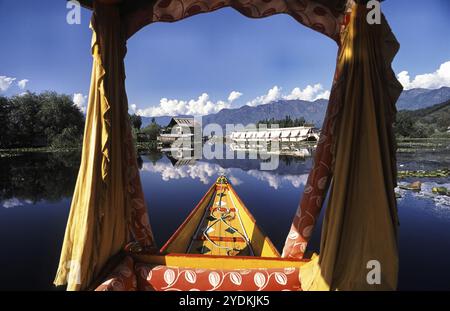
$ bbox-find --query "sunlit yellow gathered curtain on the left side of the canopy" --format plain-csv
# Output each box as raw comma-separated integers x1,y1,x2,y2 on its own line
54,1,153,290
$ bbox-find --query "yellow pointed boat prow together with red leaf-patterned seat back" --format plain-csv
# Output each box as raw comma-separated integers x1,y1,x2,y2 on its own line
97,176,307,290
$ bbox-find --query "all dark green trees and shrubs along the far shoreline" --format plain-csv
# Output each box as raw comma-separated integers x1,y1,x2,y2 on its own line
0,91,450,157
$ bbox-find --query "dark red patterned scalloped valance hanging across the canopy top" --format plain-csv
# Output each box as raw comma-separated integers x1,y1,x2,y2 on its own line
125,0,349,42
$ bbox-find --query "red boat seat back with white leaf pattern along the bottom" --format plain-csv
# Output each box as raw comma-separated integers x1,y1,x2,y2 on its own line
96,256,301,291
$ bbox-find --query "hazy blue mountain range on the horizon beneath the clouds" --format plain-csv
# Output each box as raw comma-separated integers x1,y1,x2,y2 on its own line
142,87,450,127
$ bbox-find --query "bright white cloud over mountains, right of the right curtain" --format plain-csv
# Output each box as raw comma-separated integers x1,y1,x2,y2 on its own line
397,61,450,90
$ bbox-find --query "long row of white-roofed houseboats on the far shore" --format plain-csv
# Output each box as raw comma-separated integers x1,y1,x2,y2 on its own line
230,126,319,143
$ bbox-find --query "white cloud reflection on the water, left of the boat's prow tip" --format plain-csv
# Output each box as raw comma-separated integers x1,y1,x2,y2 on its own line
142,162,234,185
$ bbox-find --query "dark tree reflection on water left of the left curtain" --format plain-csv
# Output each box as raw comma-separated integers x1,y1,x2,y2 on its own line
0,152,80,207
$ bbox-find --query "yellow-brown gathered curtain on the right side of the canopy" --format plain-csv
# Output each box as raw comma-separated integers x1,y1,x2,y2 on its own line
300,5,402,290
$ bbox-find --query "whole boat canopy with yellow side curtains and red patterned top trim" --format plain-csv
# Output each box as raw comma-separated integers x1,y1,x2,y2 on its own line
54,0,402,290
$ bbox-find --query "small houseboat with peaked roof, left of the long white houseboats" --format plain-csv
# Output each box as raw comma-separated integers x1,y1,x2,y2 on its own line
157,118,197,146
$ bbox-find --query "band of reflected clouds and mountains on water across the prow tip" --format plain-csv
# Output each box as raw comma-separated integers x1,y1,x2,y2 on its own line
142,156,308,189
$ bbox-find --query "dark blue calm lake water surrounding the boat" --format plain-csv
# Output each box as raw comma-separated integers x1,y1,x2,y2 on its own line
0,150,450,290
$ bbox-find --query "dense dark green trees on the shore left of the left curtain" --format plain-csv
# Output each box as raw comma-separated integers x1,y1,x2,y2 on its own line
0,92,84,149
